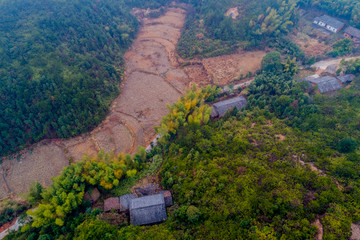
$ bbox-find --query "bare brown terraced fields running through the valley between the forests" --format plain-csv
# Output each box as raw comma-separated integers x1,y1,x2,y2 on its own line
0,5,265,198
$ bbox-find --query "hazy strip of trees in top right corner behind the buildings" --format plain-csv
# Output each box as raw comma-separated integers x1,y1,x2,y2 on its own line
299,0,360,27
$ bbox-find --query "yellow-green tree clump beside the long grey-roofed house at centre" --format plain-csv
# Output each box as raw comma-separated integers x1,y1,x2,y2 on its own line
156,86,218,138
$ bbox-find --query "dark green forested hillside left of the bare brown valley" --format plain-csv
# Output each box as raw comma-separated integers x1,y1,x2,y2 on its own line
0,0,147,155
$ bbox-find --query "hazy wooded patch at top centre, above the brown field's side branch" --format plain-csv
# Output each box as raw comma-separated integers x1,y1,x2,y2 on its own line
178,0,297,58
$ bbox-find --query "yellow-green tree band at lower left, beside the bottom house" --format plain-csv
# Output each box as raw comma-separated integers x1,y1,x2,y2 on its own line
28,150,136,227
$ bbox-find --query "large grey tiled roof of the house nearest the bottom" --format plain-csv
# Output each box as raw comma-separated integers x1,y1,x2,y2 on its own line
130,194,166,226
